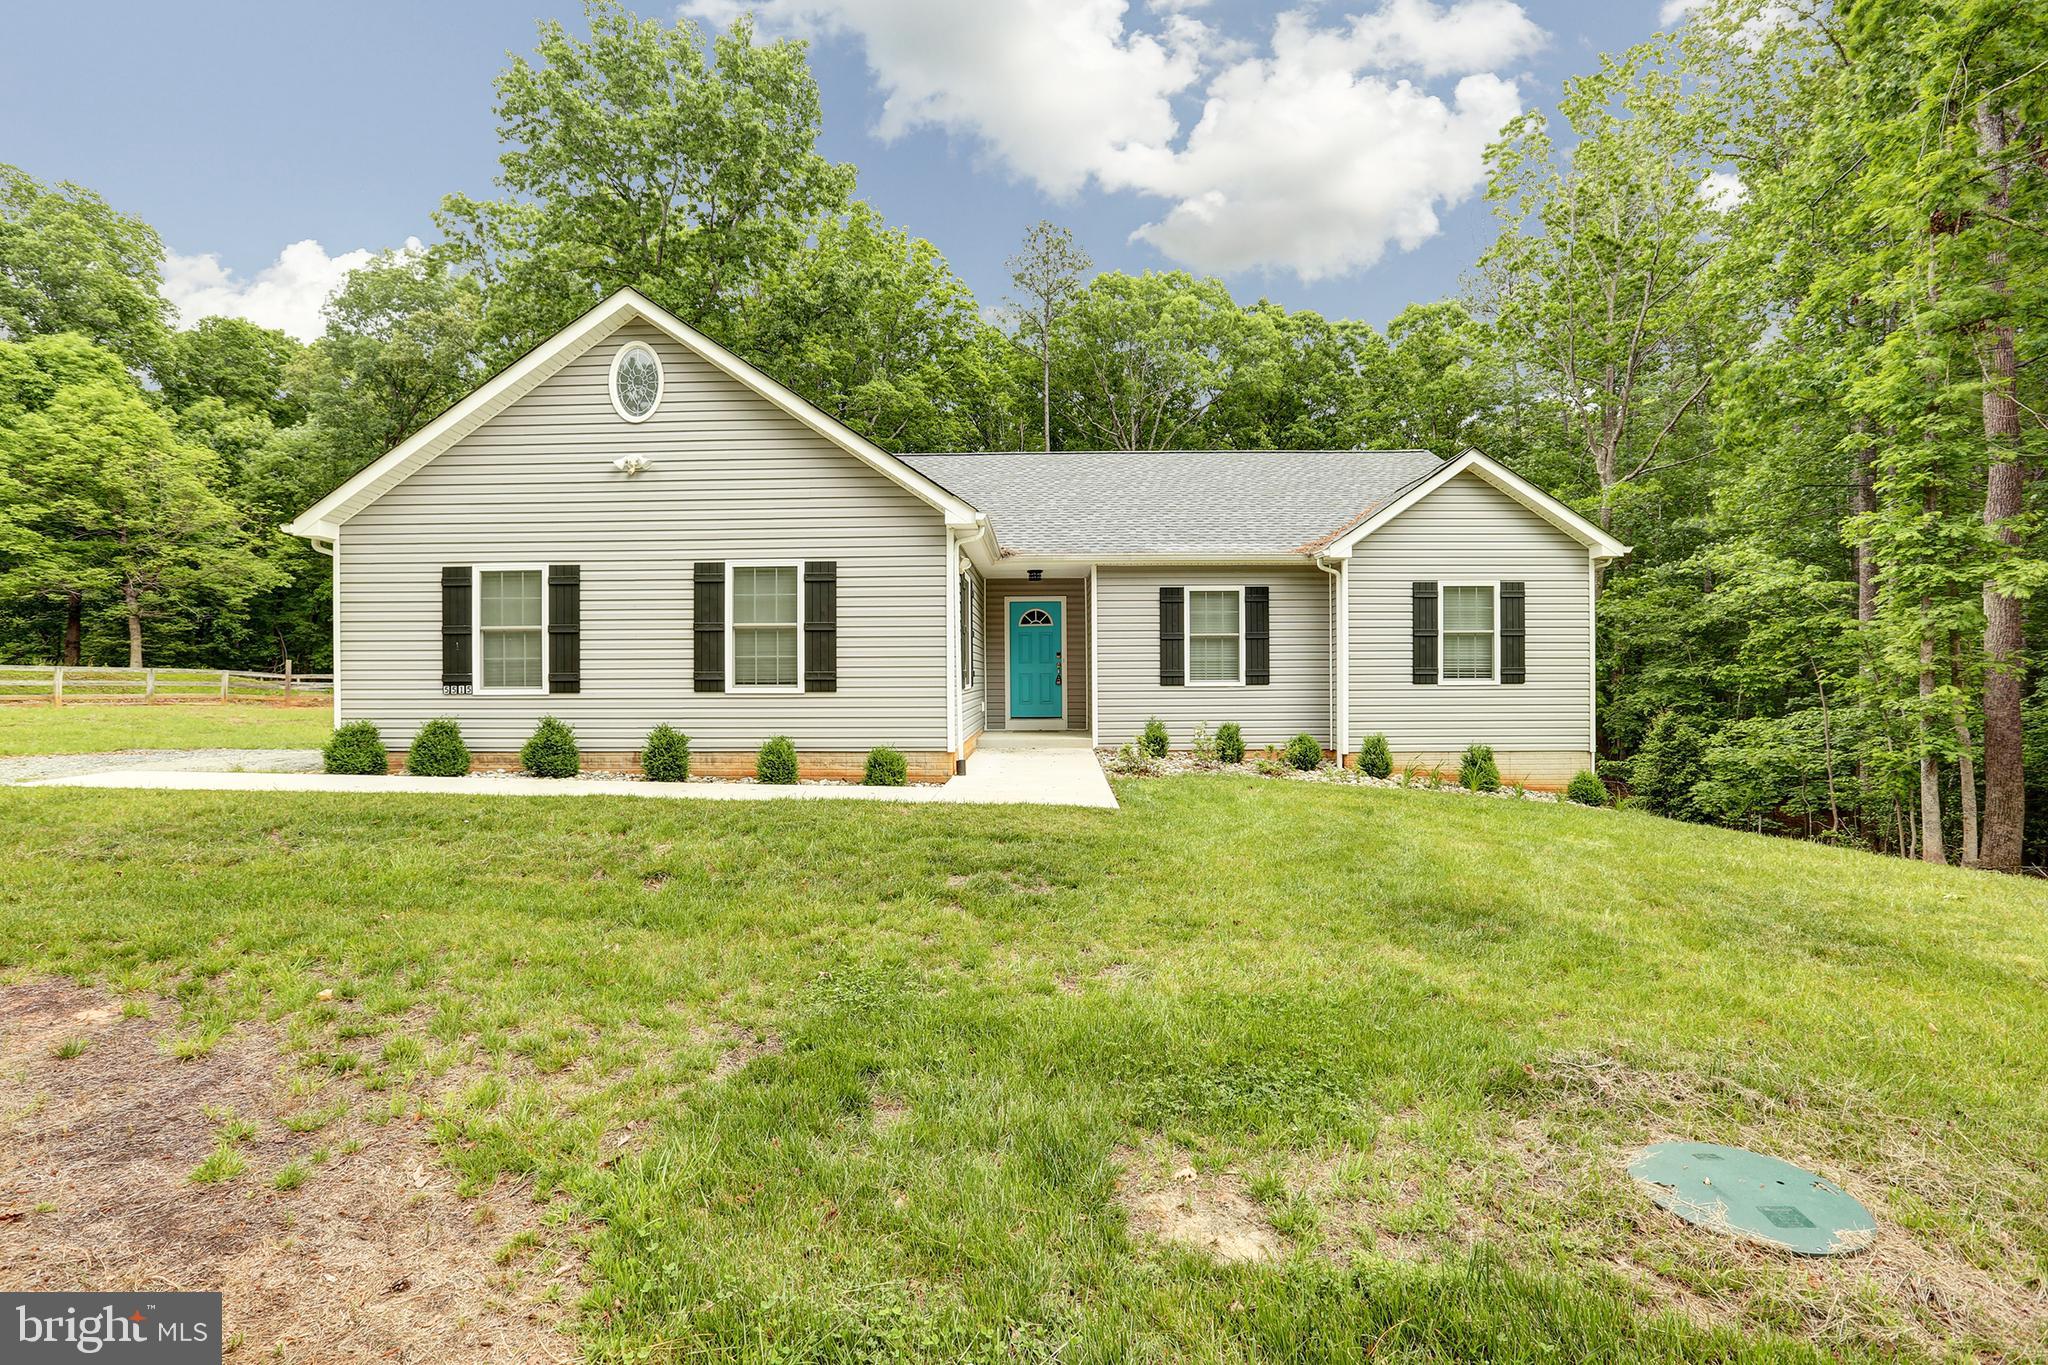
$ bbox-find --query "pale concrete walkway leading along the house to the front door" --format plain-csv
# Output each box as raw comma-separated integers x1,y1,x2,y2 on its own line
20,735,1116,810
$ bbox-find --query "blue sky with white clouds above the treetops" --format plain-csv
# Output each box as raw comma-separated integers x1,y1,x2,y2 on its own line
0,0,1686,334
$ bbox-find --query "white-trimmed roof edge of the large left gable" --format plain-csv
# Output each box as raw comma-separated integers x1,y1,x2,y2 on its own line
285,289,983,540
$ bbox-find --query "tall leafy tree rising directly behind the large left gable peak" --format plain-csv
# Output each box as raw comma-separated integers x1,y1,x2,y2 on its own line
434,0,854,368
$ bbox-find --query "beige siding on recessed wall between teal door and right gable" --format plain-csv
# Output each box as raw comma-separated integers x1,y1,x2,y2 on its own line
1096,565,1333,749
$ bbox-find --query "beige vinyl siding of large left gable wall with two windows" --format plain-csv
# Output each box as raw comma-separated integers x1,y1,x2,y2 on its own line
336,323,956,751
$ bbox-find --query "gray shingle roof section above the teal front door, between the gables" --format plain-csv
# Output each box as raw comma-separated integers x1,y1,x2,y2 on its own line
901,450,1442,555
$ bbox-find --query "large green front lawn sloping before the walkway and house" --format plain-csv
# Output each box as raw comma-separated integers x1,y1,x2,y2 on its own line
0,778,2048,1361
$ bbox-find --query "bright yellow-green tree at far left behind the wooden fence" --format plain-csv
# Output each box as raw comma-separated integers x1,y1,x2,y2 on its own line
0,336,279,667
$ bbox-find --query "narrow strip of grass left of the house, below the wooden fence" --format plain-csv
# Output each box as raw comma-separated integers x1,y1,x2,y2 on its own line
0,702,334,757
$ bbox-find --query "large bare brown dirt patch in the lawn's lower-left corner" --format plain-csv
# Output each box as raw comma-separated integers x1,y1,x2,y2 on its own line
0,982,580,1363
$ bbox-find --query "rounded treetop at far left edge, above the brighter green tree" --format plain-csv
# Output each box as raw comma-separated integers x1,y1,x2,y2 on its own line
0,164,170,370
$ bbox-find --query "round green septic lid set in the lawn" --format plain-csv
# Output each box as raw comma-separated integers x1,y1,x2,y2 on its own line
1628,1142,1878,1257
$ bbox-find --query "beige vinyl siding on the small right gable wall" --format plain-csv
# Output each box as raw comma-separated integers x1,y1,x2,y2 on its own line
1348,473,1593,778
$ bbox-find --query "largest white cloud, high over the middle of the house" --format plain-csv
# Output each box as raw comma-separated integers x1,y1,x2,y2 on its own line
682,0,1544,278
